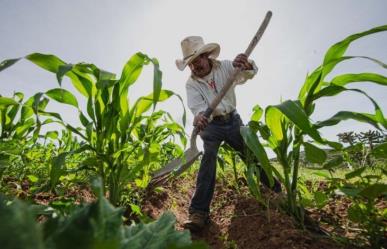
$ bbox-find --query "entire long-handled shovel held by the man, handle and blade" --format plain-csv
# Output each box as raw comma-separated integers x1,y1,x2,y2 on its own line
150,11,272,186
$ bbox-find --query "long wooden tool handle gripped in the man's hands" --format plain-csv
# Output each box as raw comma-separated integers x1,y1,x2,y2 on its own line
203,11,273,118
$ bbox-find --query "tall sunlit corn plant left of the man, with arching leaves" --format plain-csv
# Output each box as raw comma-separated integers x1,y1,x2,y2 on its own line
0,53,185,204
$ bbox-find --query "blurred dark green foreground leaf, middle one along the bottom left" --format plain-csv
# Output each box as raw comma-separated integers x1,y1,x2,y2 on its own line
44,181,124,249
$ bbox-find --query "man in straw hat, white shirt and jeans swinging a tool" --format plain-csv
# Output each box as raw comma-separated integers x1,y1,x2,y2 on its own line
176,36,281,231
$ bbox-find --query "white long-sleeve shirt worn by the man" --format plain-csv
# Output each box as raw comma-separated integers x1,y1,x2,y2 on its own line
186,60,258,117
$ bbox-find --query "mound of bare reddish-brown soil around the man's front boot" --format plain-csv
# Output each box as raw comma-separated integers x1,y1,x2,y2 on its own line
142,176,372,249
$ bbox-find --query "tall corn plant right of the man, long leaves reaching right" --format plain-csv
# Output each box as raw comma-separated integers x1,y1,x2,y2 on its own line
241,26,387,224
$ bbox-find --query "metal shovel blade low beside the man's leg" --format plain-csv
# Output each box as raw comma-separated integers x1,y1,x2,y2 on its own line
153,147,202,179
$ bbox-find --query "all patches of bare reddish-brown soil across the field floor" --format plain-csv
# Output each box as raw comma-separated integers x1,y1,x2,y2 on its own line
3,175,387,249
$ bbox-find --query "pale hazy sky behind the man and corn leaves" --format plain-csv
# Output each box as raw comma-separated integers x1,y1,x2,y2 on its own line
0,0,387,149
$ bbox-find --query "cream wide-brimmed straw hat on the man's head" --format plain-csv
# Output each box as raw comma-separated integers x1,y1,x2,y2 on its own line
176,36,220,71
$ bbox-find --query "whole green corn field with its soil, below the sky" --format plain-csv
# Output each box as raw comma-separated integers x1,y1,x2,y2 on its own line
0,26,387,248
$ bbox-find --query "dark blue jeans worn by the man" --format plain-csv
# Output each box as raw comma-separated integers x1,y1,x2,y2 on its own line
189,113,281,214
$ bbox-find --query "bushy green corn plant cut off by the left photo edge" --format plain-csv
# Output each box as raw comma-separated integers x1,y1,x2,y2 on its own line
0,92,63,184
